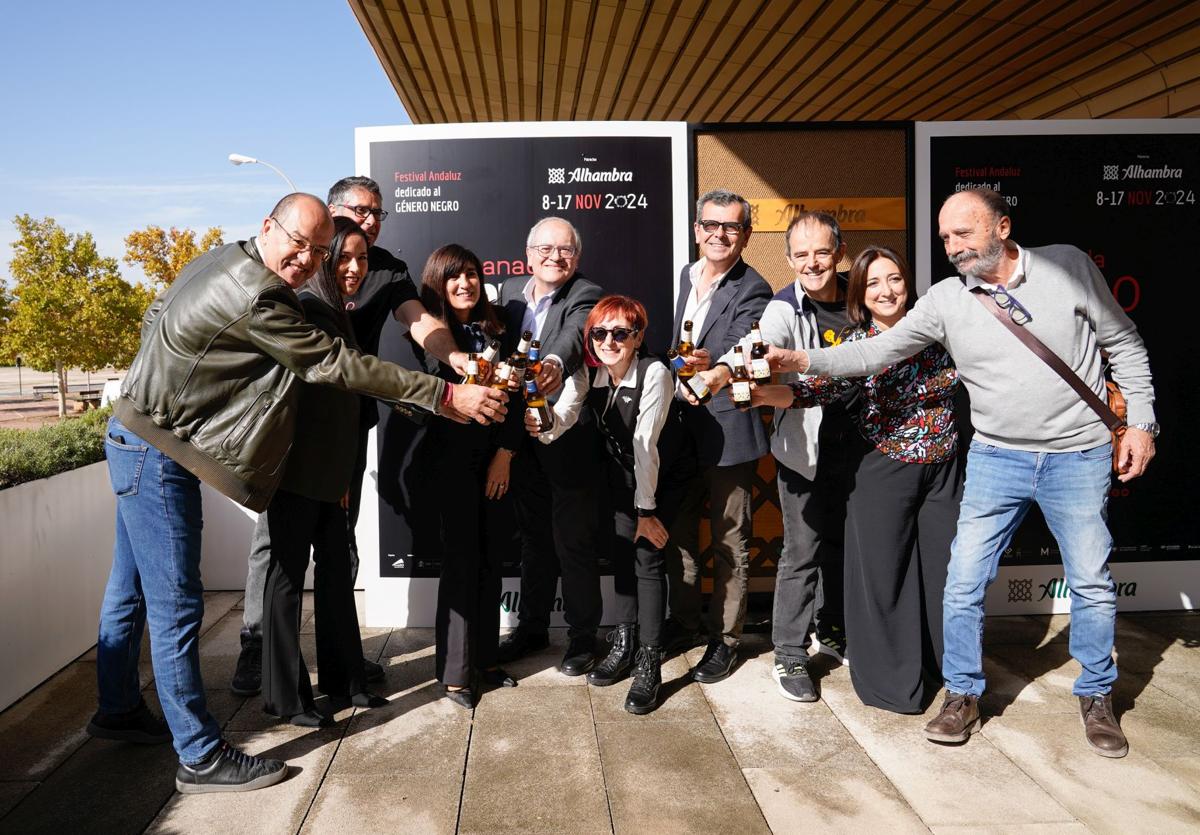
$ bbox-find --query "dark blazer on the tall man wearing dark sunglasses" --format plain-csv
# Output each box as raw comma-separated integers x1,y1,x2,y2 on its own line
671,259,772,467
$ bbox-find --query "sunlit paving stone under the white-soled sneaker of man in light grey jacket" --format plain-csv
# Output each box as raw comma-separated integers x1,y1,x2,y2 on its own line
702,653,858,769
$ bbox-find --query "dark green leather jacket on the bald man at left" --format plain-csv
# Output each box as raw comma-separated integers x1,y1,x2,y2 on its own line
114,240,445,511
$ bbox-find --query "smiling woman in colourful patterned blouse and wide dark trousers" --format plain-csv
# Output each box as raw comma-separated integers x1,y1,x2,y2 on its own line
751,246,962,714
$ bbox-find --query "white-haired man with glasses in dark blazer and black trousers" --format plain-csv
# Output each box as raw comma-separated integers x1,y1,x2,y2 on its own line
499,217,602,675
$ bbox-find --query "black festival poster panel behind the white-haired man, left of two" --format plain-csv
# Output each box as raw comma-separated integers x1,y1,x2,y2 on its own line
370,137,676,577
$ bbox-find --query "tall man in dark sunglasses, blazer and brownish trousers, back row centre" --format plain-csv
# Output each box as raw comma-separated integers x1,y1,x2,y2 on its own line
664,190,772,683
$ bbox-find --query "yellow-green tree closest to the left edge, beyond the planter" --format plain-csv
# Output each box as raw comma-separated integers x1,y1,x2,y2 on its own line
0,215,152,416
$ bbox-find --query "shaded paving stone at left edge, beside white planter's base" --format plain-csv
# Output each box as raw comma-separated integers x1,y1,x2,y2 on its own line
0,661,96,781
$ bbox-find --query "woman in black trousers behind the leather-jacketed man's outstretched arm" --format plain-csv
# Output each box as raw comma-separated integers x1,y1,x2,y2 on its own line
264,217,386,727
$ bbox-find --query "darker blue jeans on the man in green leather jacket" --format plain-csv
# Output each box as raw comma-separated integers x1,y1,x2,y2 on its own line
96,418,221,764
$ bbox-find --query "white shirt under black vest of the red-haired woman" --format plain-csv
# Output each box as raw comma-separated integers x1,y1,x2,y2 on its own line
538,360,672,510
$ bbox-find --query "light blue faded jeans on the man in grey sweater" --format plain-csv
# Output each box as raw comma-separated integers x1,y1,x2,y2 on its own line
942,440,1117,696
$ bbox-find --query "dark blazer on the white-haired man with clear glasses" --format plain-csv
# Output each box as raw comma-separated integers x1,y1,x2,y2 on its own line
500,272,604,485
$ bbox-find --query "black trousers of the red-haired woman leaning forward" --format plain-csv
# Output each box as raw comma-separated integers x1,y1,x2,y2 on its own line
606,458,688,647
